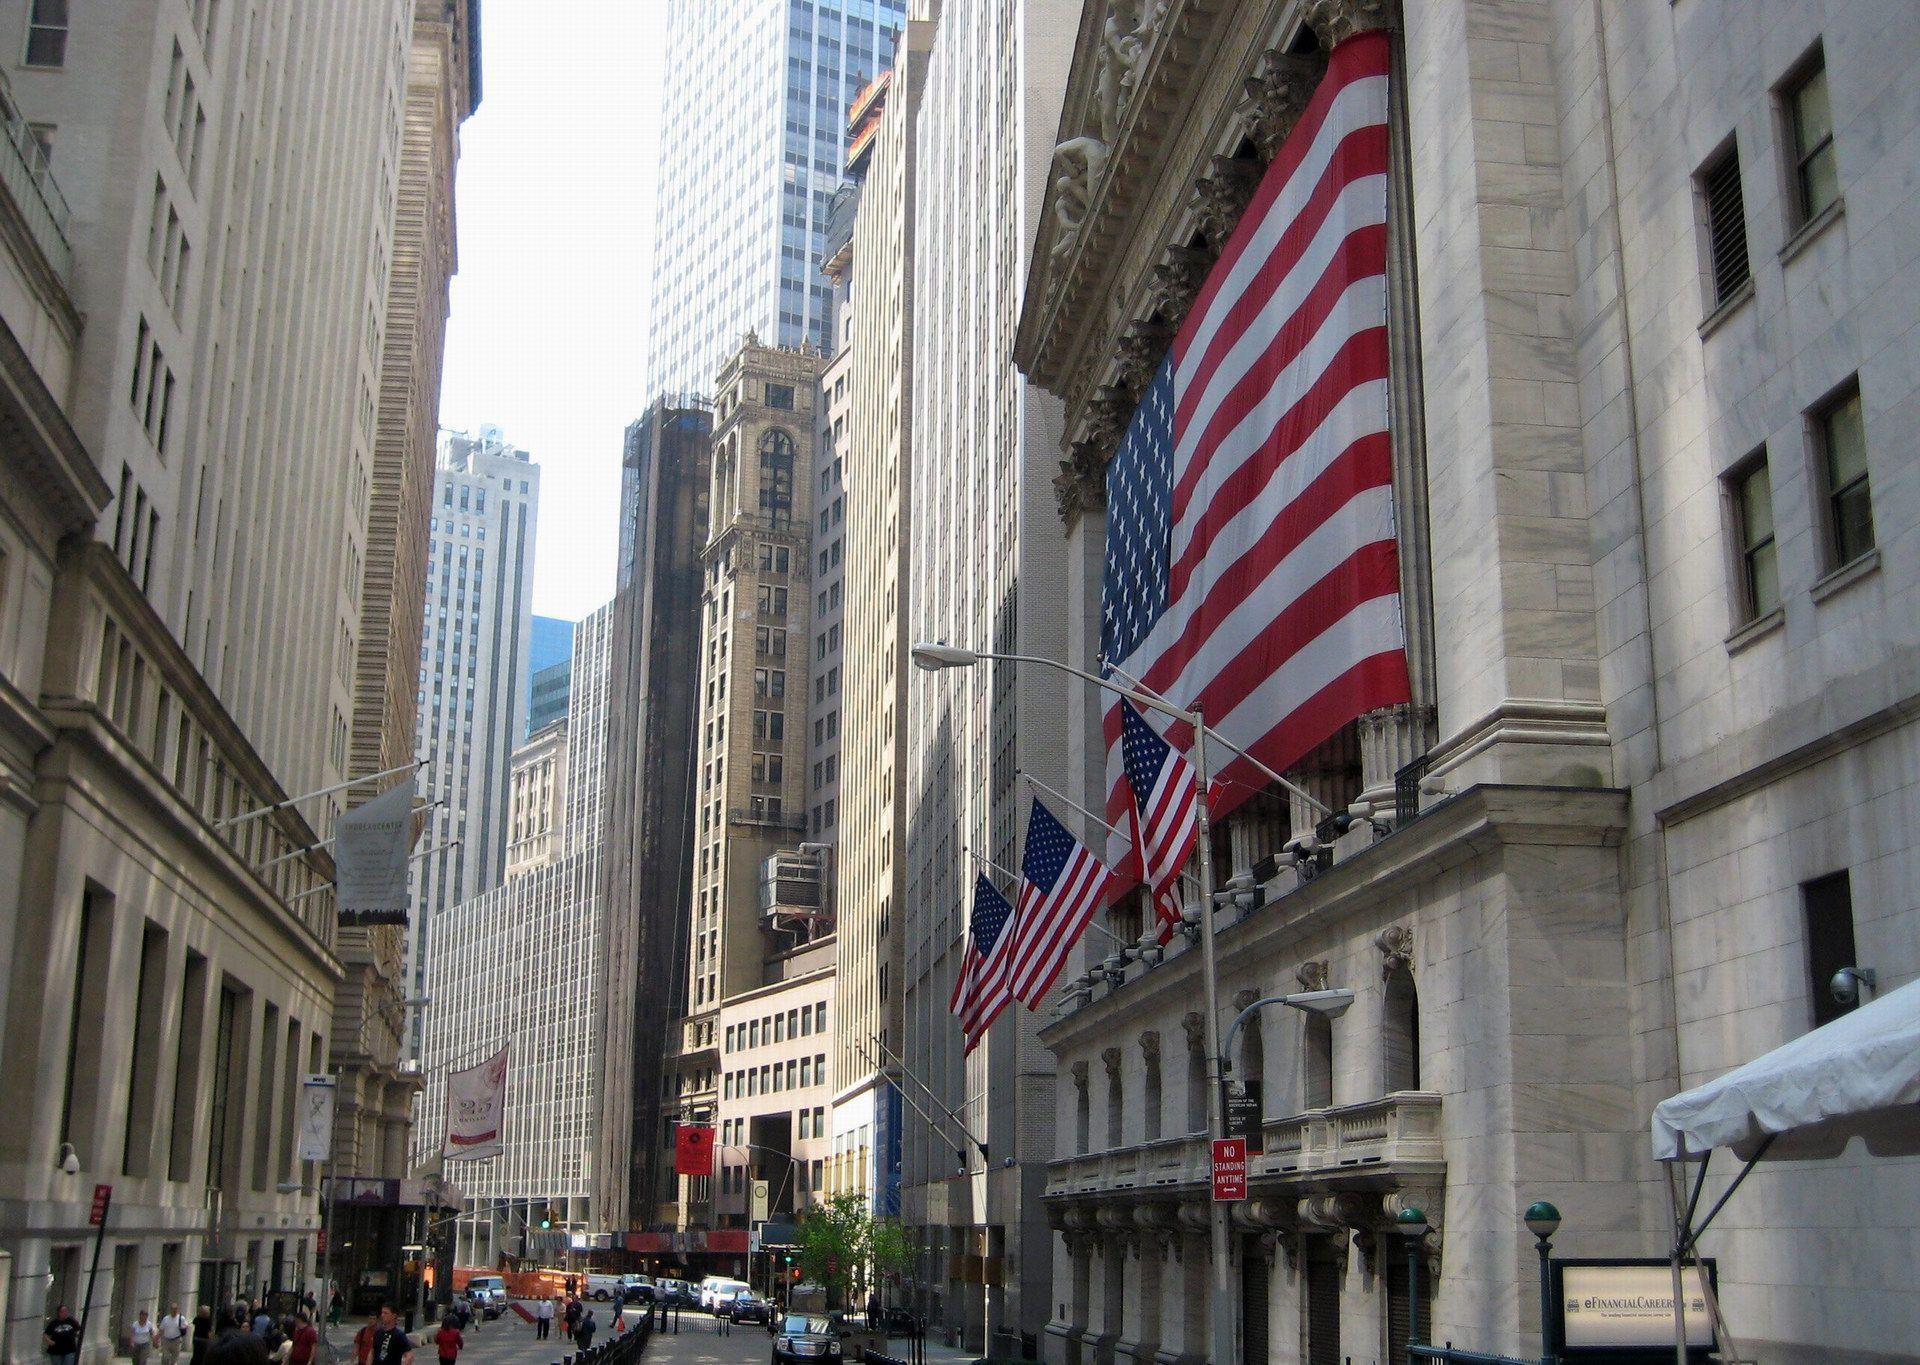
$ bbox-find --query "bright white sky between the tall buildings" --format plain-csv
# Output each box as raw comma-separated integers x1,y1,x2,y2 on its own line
440,0,666,620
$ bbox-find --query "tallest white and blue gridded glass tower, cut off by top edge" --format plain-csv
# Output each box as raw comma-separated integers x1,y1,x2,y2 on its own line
649,0,906,394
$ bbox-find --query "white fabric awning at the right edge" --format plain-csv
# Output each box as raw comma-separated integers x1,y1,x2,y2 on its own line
1653,981,1920,1161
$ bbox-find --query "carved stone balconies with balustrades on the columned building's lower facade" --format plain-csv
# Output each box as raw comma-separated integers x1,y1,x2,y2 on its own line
1046,1090,1446,1202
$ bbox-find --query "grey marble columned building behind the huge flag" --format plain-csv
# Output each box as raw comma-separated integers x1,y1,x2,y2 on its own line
1016,0,1920,1363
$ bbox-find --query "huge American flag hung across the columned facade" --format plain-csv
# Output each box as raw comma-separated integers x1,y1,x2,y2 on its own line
1100,33,1409,863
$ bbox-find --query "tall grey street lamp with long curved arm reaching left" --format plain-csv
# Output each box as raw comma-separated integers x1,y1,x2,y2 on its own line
912,643,1240,1365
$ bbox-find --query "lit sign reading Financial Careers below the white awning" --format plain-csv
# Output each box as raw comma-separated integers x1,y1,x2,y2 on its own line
1553,1257,1718,1361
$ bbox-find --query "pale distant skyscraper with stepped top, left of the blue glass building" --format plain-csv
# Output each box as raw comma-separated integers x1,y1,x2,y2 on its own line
407,426,540,1052
